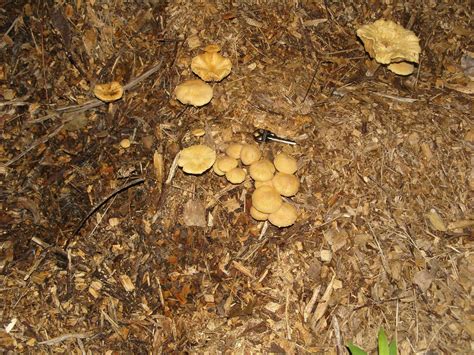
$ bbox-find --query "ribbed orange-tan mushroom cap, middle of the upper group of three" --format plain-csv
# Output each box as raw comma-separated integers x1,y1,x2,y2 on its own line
191,52,232,81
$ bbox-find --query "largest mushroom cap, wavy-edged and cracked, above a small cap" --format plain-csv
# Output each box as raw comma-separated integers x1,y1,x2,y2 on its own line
357,19,421,64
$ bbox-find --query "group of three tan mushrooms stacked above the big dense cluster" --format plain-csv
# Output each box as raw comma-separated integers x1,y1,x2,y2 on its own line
174,44,232,107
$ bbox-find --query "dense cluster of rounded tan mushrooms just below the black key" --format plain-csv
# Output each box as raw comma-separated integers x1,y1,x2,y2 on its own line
213,143,300,227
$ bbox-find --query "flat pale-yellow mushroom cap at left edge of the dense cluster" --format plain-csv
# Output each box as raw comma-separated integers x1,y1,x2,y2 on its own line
178,144,216,174
